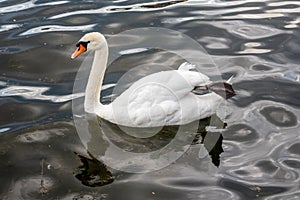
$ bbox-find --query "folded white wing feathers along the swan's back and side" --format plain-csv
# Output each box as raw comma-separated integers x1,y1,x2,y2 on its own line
108,70,220,127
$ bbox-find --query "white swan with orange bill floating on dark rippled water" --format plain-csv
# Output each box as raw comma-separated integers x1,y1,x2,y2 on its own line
71,32,234,127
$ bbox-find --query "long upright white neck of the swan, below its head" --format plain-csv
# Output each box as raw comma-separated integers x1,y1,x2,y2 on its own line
84,42,108,118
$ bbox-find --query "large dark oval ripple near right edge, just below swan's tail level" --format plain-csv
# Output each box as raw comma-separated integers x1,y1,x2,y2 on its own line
260,106,298,127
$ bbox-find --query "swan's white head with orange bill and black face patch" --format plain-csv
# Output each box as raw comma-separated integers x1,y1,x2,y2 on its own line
71,32,107,59
